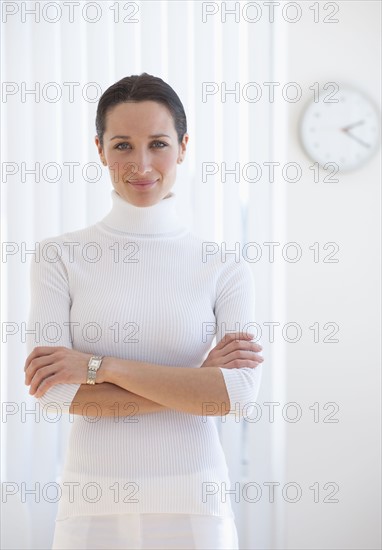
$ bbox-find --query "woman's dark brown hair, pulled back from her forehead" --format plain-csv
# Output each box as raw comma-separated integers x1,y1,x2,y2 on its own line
96,73,187,150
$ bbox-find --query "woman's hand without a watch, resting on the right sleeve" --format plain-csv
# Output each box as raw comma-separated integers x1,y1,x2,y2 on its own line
201,332,264,369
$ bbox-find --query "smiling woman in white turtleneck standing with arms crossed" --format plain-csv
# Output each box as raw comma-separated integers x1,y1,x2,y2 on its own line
25,73,262,549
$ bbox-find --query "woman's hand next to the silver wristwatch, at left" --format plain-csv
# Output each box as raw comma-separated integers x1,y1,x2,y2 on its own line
24,346,92,398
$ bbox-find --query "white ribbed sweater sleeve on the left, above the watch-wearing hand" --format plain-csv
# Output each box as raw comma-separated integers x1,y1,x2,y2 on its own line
27,239,80,413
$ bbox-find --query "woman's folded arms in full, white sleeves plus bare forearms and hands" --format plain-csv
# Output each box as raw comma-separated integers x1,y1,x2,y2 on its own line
25,240,263,416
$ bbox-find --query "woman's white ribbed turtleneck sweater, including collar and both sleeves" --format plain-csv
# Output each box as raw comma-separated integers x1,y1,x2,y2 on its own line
27,190,262,519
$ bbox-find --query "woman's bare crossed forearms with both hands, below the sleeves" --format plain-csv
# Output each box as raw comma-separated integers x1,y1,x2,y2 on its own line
24,332,263,416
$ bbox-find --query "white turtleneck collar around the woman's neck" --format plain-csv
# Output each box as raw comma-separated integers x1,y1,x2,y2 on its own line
100,189,185,236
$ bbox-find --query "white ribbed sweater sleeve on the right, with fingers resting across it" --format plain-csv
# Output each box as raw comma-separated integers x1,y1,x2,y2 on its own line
215,260,262,418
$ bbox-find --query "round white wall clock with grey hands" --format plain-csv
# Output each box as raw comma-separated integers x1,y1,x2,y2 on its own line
300,87,380,171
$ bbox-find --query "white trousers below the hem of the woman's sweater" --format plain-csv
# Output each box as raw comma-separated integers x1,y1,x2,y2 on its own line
52,514,239,550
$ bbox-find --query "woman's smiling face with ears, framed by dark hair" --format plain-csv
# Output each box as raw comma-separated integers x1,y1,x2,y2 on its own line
95,101,188,206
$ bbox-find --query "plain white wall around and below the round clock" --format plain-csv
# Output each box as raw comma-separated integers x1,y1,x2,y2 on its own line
275,1,381,549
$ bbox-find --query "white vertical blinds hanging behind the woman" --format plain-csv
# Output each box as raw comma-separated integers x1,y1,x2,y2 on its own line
1,1,281,548
